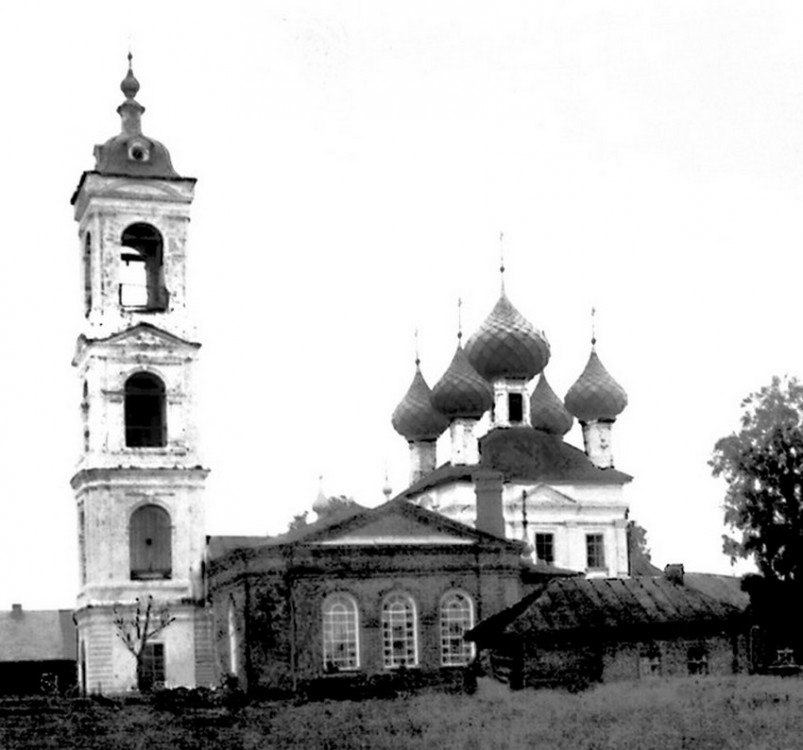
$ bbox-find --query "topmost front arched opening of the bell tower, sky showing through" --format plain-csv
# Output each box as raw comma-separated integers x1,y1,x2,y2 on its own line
120,224,167,312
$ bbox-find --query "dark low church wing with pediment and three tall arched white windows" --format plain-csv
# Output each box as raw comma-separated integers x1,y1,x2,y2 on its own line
208,494,572,694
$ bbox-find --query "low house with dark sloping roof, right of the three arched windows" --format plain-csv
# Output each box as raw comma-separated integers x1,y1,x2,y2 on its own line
466,565,749,687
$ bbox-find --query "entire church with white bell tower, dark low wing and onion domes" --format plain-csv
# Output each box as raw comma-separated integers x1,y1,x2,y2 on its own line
59,55,704,693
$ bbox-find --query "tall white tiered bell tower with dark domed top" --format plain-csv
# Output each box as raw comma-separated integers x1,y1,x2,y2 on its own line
71,54,213,693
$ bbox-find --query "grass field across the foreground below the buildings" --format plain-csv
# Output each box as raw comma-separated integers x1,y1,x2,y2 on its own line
0,676,803,750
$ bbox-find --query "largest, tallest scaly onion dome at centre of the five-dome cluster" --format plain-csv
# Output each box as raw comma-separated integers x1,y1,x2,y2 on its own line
466,293,549,382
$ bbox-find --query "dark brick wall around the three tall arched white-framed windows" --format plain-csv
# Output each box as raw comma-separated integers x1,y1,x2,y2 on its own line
210,545,521,692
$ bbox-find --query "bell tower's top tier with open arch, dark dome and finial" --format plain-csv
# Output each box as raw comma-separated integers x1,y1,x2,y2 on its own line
72,54,195,335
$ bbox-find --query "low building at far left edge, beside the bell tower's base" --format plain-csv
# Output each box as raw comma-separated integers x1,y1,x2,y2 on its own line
0,604,76,695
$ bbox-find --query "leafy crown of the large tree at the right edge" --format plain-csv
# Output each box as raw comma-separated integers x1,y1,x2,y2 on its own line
710,377,803,586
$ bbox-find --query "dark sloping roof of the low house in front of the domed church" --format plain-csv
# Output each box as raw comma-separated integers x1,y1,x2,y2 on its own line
467,576,742,642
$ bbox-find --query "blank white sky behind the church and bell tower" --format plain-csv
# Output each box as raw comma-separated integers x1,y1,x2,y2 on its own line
0,0,803,609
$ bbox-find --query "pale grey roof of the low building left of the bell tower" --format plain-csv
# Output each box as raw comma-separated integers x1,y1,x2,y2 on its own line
0,609,76,662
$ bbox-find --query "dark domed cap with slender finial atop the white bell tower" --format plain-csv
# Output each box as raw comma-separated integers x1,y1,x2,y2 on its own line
95,52,178,177
